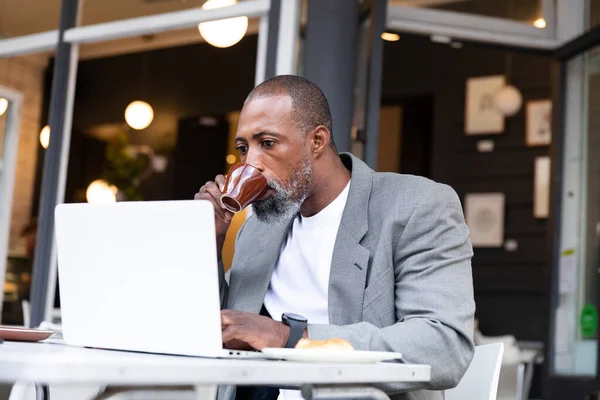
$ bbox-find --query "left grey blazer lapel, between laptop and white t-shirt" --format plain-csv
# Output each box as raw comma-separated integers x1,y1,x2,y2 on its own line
227,219,293,314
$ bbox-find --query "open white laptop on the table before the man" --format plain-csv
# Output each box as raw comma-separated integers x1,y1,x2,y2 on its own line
55,200,265,358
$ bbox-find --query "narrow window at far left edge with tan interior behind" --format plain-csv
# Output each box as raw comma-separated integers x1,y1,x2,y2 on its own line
0,56,47,325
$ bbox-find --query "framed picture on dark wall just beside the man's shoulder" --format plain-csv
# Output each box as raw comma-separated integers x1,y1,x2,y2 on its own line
465,193,505,247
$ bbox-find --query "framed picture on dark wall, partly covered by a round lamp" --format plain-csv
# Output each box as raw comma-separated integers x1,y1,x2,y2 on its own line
465,75,506,135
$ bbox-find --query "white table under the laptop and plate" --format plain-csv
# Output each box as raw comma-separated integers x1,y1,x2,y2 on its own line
0,342,431,398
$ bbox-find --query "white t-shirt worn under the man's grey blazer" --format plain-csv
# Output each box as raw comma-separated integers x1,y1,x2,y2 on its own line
264,182,350,400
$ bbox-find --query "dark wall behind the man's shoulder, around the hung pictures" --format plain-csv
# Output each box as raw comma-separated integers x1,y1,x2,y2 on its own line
382,35,551,340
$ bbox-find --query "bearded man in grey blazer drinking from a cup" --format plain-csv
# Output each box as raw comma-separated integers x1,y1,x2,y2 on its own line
196,76,475,400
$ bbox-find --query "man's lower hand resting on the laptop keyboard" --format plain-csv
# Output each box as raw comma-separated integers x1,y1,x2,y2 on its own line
221,310,290,350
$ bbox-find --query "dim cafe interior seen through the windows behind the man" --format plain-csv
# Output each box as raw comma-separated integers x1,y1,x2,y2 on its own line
0,0,600,398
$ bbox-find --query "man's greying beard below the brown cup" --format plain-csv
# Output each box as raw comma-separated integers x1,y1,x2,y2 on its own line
252,158,312,224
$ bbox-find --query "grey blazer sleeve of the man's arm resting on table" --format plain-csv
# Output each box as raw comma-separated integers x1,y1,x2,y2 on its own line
308,184,475,392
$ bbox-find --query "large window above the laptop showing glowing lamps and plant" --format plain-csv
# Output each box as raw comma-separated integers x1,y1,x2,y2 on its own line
69,28,258,268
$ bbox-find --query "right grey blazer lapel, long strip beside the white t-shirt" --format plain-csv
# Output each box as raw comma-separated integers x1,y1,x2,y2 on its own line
329,154,373,325
